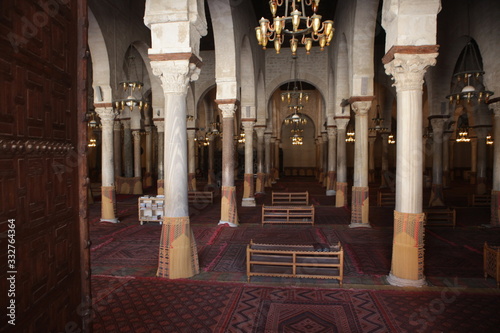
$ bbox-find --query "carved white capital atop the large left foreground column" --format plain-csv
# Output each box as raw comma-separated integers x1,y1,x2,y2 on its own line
151,59,200,95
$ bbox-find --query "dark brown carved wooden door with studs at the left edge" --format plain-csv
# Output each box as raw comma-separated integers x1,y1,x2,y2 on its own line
0,0,90,332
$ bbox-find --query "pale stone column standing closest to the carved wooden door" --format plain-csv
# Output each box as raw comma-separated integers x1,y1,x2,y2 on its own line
95,105,120,223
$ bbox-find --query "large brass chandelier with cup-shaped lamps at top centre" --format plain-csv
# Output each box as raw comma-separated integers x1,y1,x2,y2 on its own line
255,0,335,55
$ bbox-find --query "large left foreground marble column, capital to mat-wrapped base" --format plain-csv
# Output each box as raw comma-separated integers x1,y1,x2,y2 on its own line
149,58,201,279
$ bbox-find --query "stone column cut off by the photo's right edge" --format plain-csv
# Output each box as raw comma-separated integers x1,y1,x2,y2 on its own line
490,102,500,227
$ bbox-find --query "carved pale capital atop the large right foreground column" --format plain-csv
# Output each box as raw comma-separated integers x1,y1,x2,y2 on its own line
384,53,438,92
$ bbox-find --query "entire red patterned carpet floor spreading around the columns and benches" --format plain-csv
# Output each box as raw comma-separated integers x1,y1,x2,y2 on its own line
90,179,500,333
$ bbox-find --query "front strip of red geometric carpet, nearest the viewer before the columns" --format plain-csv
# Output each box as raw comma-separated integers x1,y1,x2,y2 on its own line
92,277,500,333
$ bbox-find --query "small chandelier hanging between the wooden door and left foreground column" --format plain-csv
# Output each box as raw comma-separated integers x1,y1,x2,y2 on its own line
113,56,149,112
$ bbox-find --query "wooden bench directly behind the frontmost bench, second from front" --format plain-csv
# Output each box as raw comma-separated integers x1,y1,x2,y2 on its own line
262,205,314,225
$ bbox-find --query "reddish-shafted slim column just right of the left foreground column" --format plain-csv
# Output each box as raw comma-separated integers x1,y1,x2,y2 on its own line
216,100,239,227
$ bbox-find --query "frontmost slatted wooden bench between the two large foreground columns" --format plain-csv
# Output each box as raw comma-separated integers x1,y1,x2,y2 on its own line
247,241,344,287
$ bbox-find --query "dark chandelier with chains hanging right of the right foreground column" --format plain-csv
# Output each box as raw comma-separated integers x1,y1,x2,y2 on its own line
446,38,493,104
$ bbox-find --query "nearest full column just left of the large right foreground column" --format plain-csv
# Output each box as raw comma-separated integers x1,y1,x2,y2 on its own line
349,100,373,228
